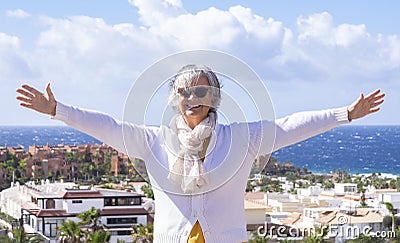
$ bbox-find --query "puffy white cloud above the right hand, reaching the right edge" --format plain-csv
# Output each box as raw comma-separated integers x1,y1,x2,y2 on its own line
262,12,399,83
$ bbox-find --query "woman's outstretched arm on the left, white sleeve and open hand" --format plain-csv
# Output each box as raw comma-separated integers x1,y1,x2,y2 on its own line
17,83,158,159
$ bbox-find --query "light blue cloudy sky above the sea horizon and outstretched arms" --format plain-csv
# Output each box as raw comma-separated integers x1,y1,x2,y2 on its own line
0,0,400,125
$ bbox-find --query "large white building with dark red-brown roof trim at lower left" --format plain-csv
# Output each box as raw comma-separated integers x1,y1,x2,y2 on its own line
0,182,148,242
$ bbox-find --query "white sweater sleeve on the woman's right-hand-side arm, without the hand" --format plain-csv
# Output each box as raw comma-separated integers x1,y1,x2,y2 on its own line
250,107,349,155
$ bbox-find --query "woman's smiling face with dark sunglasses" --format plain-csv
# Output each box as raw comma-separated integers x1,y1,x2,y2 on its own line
178,76,211,129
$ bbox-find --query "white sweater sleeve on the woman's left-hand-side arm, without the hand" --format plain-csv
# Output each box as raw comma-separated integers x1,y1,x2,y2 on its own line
52,102,155,159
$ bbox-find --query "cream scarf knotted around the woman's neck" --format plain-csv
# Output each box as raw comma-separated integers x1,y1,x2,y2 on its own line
168,112,217,193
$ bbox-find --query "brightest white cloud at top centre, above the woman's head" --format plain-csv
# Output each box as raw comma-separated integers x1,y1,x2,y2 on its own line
126,0,286,60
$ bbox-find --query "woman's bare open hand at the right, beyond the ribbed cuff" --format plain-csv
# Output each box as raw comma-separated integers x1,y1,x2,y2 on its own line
347,89,385,121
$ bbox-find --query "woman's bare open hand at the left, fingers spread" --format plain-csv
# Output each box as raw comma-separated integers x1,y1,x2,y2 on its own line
16,83,57,116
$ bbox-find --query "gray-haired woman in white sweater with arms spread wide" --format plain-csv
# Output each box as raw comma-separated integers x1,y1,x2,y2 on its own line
17,65,384,243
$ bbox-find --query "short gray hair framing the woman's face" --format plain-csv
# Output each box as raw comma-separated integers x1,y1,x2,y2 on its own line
168,64,221,112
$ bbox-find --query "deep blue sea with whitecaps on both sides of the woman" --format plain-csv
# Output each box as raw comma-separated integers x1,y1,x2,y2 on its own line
0,126,400,175
